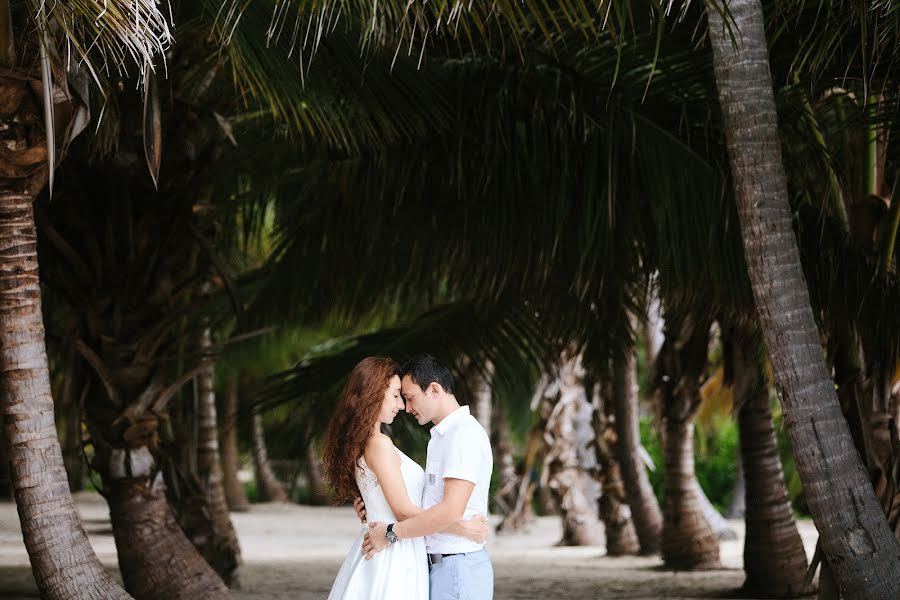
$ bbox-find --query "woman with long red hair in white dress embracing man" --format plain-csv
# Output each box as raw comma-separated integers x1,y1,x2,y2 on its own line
325,357,487,600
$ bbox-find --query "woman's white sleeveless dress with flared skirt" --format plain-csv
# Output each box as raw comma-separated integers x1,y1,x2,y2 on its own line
328,448,428,600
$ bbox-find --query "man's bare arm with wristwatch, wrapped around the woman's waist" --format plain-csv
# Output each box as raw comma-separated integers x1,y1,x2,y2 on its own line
362,478,475,558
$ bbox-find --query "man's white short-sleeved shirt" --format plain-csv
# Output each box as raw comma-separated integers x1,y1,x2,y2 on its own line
422,406,494,554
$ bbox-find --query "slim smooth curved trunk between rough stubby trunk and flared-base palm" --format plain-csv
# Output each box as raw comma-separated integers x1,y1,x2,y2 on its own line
613,348,663,555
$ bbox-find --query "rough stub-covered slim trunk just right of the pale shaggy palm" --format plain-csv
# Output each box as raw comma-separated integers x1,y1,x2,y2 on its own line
590,384,641,556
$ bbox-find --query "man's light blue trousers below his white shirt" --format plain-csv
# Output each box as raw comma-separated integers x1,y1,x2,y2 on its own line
428,550,494,600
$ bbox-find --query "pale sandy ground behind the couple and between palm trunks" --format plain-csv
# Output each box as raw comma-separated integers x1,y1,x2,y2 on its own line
0,493,817,600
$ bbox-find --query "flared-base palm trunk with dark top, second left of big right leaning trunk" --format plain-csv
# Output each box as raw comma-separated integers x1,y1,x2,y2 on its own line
655,316,719,569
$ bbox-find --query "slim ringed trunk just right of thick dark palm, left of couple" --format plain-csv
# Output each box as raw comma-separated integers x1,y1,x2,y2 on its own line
197,328,241,585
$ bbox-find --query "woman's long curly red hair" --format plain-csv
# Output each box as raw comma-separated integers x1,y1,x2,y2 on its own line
324,356,400,503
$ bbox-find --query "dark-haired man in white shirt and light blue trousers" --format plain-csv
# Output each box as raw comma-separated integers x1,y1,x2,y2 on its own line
361,355,494,600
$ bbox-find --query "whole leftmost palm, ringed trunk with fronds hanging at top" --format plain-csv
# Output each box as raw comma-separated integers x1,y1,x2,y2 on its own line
0,1,169,598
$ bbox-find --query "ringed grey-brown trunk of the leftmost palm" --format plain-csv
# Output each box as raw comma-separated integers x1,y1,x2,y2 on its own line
0,189,129,600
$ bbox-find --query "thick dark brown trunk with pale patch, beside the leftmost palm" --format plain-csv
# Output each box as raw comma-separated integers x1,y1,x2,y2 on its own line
41,204,229,599
